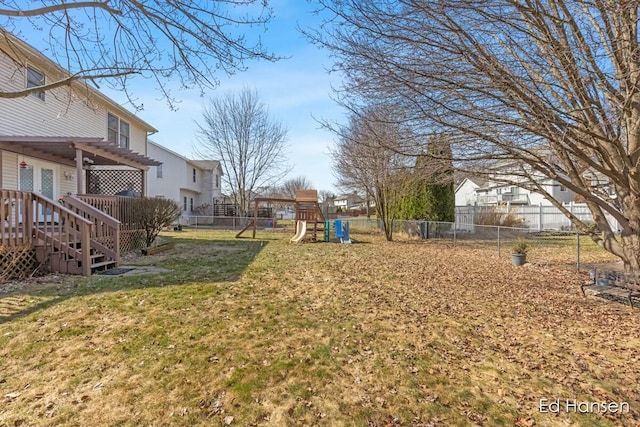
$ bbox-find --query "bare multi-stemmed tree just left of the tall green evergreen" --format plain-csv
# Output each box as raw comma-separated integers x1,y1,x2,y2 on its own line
331,108,411,241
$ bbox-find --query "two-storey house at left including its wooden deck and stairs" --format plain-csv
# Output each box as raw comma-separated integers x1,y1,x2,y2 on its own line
0,28,160,275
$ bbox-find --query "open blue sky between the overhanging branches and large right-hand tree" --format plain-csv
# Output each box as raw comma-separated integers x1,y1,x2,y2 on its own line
102,0,344,191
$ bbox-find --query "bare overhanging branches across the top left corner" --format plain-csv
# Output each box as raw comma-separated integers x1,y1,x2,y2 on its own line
0,0,277,106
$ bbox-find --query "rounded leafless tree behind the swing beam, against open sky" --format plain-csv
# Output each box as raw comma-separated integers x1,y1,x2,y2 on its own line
195,89,290,216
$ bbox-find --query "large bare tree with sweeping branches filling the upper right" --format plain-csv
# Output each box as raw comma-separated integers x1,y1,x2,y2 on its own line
310,0,640,272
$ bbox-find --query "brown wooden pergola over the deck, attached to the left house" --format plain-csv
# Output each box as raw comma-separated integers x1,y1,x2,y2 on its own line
0,136,161,195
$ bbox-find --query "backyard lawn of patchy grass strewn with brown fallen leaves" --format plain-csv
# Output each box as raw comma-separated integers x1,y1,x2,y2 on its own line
0,230,640,427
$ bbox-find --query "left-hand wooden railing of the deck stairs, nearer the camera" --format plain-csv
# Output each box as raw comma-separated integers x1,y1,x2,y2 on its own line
32,193,93,276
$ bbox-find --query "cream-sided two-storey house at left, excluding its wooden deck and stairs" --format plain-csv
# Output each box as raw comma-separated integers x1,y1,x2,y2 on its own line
0,32,156,199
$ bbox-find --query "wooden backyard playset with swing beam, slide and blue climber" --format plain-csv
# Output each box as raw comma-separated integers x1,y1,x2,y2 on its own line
236,190,351,243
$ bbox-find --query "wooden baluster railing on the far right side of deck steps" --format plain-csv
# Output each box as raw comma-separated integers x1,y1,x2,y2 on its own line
62,196,120,264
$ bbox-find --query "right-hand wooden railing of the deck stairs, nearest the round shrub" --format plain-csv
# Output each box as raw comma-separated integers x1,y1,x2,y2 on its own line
62,195,121,265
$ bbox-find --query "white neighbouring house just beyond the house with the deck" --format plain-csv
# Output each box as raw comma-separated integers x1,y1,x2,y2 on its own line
148,141,224,215
